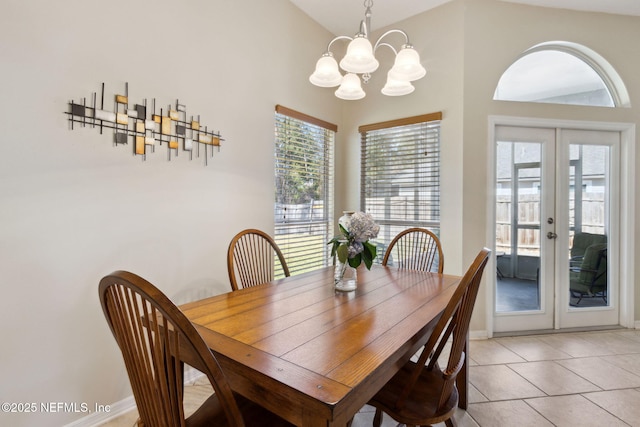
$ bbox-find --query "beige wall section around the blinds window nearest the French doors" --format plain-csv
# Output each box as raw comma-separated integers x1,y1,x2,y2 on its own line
336,1,464,274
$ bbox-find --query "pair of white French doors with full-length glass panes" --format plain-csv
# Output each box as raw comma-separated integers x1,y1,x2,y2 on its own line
494,126,620,332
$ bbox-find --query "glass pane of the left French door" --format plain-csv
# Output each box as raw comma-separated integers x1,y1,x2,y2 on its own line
496,141,542,312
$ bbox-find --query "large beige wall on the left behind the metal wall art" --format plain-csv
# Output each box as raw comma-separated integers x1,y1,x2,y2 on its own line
0,0,341,426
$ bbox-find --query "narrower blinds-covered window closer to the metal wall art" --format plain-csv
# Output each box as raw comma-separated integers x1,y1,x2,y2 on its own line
274,105,338,275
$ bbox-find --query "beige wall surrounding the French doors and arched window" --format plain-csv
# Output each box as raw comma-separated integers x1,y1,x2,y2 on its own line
462,0,640,331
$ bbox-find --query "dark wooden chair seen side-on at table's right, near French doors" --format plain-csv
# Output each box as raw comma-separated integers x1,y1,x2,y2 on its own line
369,248,491,427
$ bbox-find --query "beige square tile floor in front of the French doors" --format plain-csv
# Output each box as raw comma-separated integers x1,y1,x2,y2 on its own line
99,329,640,427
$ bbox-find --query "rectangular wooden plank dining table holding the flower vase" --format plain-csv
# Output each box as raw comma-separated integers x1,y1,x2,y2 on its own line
180,265,466,427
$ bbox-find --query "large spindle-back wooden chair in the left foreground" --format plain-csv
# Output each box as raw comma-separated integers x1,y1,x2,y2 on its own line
99,271,291,427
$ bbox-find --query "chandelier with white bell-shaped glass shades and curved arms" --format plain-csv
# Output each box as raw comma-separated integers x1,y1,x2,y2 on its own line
309,0,427,100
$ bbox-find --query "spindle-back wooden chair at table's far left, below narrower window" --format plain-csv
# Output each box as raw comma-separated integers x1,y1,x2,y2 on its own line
227,228,289,291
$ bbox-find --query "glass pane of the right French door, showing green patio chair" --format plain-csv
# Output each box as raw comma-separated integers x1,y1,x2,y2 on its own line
568,144,609,308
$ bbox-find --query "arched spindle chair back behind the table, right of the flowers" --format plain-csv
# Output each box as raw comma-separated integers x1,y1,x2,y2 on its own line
382,227,444,274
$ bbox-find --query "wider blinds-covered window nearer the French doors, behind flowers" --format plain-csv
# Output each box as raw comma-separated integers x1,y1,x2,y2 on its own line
358,112,442,261
